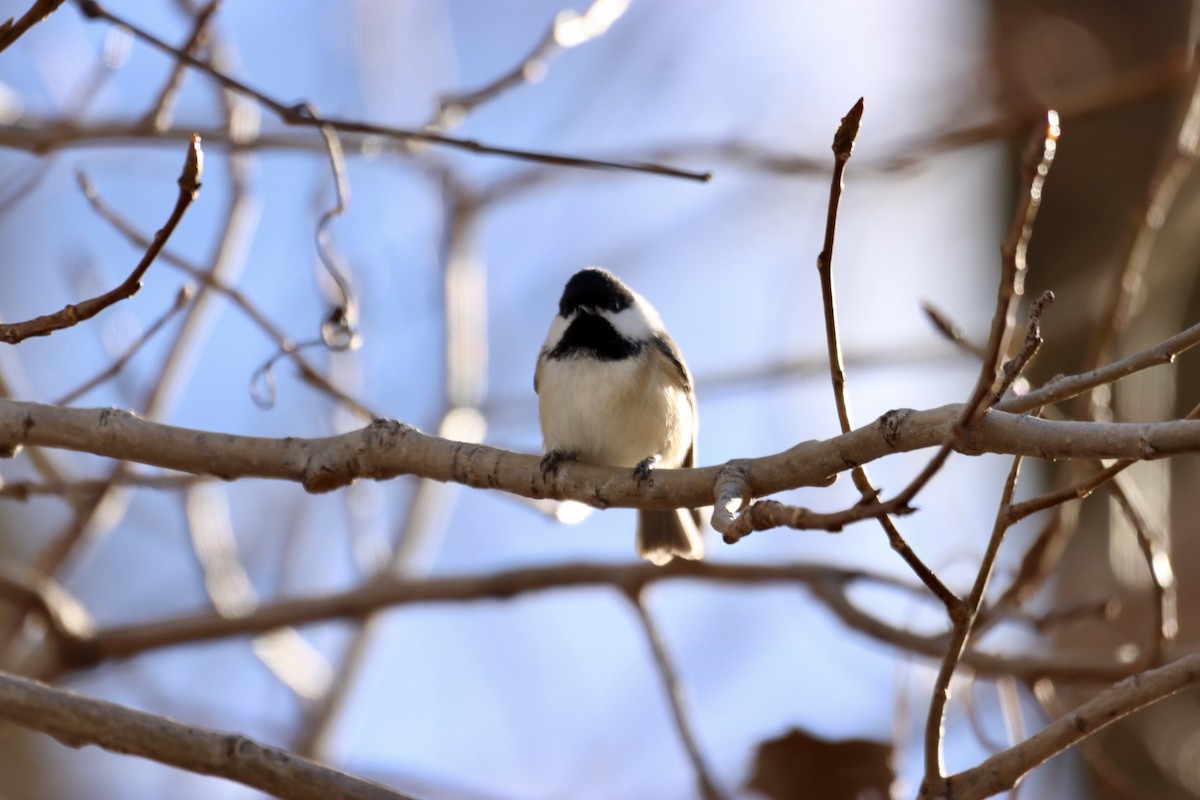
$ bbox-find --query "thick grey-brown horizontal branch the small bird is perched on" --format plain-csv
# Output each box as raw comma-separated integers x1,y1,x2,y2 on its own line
0,399,1200,509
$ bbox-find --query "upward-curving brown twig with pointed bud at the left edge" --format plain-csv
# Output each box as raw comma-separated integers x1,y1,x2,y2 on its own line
0,134,204,344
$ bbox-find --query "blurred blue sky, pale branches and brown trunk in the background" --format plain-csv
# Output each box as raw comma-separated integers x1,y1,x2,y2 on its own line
0,0,1200,800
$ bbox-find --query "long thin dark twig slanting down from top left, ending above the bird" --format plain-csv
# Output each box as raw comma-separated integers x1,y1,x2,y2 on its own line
76,0,713,182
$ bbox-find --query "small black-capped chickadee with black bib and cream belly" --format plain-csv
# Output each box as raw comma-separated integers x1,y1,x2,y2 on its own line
533,266,704,565
